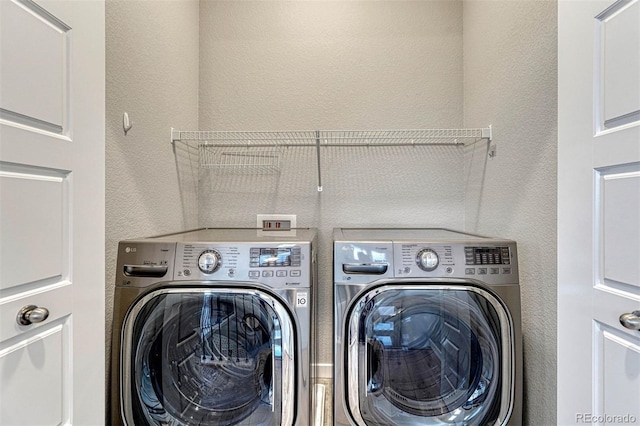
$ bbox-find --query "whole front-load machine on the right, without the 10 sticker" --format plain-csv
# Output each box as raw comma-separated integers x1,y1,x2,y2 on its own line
333,228,522,426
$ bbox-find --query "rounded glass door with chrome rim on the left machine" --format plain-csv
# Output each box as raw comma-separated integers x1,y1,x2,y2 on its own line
121,287,296,426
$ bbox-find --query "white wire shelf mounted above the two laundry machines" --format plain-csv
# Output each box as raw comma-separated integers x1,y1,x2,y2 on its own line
171,126,495,191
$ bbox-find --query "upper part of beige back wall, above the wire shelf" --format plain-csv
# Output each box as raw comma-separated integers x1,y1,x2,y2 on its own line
200,0,462,130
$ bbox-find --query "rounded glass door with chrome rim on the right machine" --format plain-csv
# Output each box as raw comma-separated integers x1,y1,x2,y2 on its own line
344,284,514,426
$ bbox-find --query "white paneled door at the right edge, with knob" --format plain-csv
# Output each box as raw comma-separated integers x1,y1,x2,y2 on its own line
558,0,640,425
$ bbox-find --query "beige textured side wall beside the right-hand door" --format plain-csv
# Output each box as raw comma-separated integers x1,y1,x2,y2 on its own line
464,0,557,425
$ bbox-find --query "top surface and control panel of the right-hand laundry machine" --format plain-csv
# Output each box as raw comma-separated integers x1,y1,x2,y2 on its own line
333,228,519,285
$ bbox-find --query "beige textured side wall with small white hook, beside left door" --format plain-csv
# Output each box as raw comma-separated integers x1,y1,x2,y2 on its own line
105,0,198,404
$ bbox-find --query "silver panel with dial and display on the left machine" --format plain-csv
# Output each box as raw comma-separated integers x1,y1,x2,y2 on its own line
174,243,312,288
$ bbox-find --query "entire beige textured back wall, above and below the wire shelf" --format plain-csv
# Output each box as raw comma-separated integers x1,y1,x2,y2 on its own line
199,0,464,372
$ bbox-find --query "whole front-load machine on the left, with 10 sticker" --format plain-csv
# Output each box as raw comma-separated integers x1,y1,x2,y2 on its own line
111,229,316,426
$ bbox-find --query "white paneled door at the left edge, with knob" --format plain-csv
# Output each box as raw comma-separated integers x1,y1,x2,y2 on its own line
0,0,105,426
